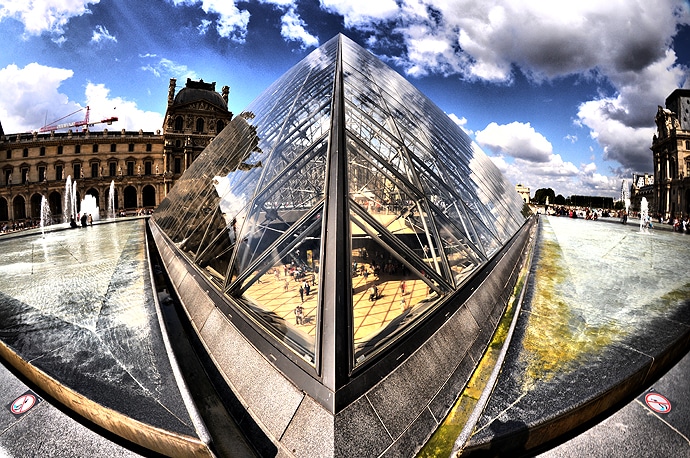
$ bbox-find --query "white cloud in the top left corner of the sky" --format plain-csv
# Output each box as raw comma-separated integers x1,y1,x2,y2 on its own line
0,0,100,35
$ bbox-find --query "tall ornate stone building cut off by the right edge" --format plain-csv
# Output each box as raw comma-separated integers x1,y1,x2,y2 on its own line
648,89,690,218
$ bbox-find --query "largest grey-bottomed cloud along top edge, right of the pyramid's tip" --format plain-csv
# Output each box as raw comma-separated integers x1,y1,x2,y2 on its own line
362,0,690,82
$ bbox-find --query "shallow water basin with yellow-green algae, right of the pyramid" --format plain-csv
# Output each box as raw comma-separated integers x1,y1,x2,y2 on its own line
463,217,690,456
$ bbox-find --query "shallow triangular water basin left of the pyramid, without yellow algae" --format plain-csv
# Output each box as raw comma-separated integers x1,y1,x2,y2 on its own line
0,220,202,456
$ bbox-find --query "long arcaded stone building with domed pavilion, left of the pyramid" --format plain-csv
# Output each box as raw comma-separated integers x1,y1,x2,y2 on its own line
0,79,232,223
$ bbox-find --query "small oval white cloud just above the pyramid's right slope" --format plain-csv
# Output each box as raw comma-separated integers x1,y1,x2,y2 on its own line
475,122,553,162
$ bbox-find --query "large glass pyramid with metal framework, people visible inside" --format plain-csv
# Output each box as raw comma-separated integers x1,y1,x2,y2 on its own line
153,35,525,390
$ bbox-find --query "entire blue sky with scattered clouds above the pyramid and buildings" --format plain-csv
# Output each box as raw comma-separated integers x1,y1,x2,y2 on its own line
0,0,690,197
